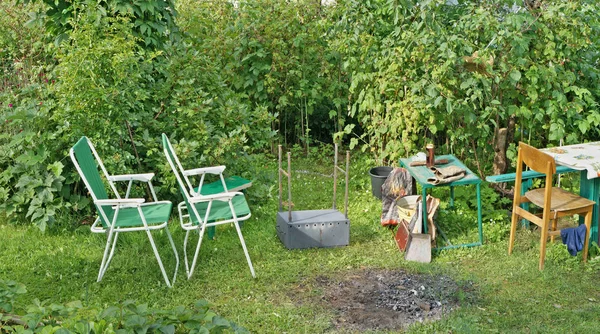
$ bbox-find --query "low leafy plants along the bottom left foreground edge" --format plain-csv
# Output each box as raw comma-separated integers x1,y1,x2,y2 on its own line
0,280,248,333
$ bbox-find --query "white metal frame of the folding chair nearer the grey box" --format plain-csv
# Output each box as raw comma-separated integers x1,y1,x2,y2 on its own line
163,133,256,279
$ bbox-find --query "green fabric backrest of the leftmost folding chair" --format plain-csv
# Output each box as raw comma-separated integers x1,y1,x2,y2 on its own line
69,136,121,226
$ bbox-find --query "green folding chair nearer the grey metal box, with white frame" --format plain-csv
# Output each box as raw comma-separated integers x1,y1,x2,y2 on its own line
162,133,256,279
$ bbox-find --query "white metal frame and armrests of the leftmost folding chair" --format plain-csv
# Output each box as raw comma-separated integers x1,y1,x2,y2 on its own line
69,138,179,287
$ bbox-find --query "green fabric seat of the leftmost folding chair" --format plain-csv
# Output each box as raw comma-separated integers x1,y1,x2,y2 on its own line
102,202,173,227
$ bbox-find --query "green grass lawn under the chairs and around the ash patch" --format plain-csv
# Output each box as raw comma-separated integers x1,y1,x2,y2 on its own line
0,153,600,333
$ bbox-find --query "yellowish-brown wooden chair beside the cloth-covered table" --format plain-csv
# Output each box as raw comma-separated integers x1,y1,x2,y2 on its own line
508,142,596,270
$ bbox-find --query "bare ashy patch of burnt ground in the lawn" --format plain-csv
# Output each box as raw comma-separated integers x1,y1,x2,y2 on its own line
315,270,474,332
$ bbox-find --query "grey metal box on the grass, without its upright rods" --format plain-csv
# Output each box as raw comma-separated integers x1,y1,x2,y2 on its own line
277,209,350,249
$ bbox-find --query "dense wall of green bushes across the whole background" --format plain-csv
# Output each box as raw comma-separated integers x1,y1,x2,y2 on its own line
0,0,600,229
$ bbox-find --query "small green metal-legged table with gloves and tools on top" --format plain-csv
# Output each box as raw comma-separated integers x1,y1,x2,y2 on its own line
400,154,483,250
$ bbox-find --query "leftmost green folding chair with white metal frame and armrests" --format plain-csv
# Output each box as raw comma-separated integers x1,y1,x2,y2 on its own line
70,137,179,287
